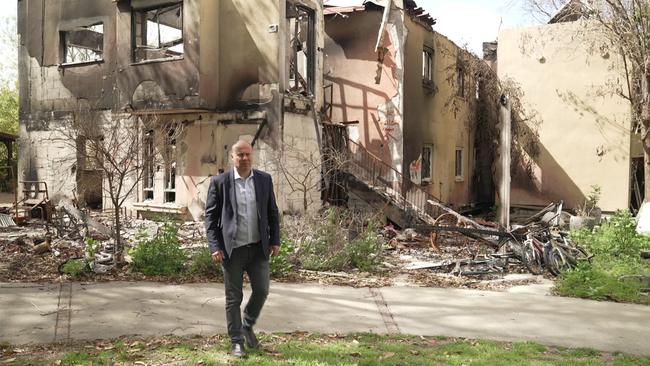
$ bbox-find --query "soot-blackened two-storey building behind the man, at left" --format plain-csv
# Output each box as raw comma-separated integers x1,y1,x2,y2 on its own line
18,0,323,220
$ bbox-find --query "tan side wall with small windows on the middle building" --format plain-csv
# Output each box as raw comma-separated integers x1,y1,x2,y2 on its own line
404,19,476,206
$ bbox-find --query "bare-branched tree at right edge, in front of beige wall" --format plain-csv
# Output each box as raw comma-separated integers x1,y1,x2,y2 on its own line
525,0,650,202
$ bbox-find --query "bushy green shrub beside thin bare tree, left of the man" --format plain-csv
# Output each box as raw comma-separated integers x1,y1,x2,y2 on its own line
129,223,187,275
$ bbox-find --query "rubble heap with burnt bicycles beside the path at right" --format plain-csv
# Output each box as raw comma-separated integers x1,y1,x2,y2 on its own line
382,203,591,284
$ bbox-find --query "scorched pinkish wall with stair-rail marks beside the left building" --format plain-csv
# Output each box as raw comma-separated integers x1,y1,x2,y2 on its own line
323,10,401,160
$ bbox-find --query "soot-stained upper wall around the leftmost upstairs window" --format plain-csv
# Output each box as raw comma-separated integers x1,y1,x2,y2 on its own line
18,0,116,115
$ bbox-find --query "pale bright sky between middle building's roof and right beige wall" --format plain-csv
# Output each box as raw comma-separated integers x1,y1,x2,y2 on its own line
415,0,538,56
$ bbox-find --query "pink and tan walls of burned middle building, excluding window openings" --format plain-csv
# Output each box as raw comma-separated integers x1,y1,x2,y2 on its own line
324,5,475,206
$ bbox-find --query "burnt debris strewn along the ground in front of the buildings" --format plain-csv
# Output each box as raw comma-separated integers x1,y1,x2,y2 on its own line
0,202,589,290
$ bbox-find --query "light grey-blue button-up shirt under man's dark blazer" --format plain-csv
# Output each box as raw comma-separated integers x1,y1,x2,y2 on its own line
233,168,260,248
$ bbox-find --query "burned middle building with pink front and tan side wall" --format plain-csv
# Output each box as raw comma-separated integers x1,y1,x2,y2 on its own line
323,0,478,209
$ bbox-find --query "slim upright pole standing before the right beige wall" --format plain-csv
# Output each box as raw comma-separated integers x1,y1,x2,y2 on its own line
498,94,512,229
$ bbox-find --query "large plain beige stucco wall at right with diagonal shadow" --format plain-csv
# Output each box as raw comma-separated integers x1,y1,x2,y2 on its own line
498,22,631,211
